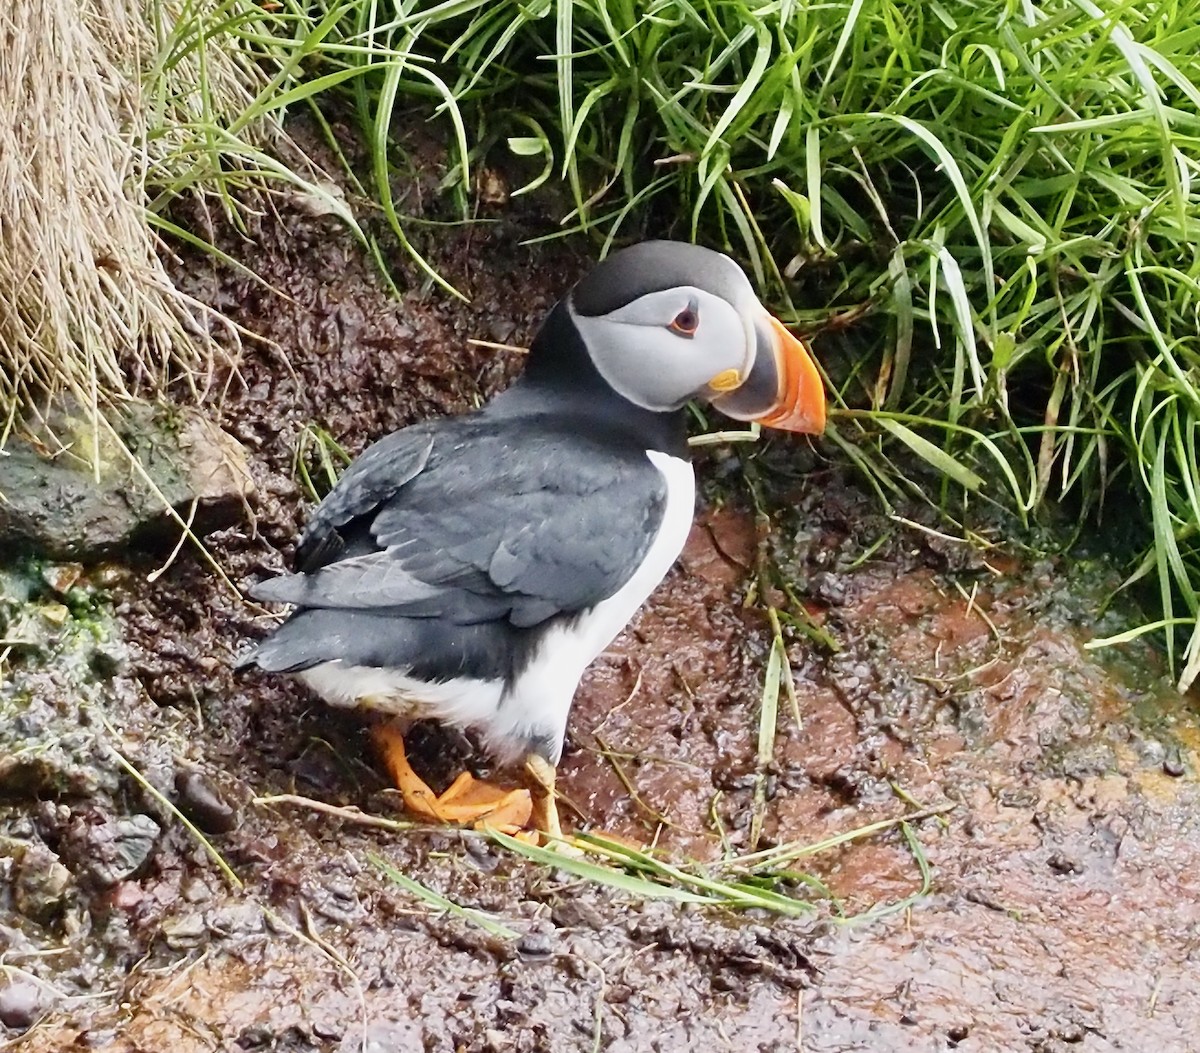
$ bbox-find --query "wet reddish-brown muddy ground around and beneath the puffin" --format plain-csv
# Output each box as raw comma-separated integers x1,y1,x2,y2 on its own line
0,119,1200,1053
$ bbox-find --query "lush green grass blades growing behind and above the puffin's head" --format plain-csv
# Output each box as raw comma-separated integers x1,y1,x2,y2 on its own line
147,0,1200,685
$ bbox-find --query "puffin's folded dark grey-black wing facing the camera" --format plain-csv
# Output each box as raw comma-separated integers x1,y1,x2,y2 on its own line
253,417,667,627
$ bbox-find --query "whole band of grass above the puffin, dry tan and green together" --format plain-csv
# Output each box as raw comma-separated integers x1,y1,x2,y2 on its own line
9,0,1200,686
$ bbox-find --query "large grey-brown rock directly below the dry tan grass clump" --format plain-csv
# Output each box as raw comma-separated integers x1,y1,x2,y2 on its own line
0,403,254,563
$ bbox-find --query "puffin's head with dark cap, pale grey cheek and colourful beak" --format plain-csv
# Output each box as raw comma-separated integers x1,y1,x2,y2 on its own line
565,241,826,434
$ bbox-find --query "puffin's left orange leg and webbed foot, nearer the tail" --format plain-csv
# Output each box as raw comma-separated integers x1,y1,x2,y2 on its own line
371,724,533,836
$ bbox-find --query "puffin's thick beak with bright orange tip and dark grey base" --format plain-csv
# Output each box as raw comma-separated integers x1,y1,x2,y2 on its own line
712,312,826,435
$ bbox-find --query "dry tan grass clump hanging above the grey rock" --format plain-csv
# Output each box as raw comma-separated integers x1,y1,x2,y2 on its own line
0,0,285,455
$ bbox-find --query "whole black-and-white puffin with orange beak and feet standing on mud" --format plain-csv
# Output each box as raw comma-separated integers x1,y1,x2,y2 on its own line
238,241,826,843
